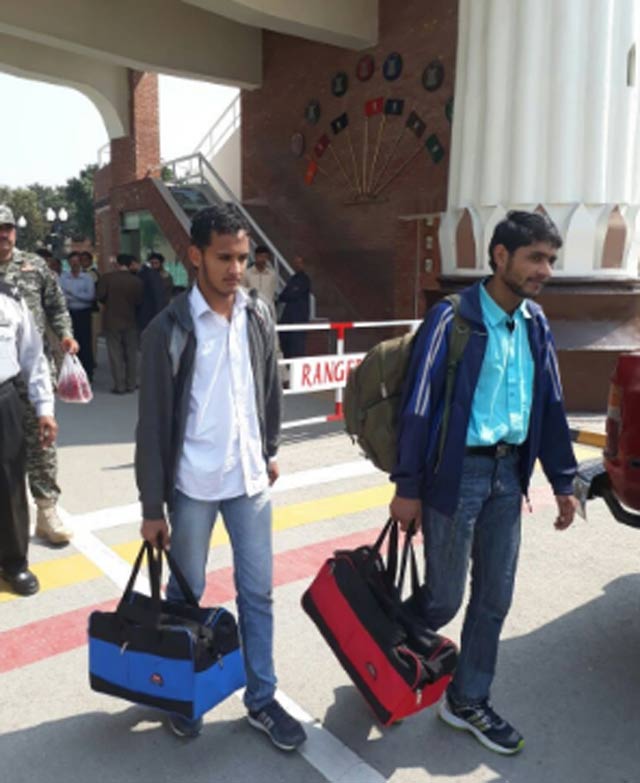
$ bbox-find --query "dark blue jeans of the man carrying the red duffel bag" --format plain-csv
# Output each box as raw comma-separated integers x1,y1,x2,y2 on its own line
422,454,522,703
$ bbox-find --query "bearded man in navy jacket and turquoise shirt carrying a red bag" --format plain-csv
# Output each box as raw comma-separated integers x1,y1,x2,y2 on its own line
390,212,576,754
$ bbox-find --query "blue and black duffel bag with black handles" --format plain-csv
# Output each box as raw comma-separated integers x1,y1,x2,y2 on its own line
89,542,246,718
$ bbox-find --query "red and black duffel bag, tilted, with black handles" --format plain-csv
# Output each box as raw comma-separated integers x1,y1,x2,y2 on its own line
302,520,457,726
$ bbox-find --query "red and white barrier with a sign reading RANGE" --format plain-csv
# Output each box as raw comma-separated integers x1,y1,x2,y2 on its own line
276,320,420,429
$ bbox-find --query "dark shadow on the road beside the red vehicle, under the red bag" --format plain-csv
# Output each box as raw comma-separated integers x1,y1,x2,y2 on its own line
324,568,640,783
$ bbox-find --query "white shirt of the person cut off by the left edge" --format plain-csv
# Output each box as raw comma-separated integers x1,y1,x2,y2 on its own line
0,291,53,416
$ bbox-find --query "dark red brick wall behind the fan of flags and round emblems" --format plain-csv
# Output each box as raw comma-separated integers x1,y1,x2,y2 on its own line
242,0,457,319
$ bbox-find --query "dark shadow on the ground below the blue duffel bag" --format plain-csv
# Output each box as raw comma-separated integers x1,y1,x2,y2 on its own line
0,706,317,783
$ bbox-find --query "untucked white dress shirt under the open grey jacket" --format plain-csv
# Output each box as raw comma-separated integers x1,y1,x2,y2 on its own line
176,285,269,500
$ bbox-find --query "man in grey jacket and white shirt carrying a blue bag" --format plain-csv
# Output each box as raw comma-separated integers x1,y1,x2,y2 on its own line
136,207,306,750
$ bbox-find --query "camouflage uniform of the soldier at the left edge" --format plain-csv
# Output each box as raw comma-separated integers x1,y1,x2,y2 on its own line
0,248,73,502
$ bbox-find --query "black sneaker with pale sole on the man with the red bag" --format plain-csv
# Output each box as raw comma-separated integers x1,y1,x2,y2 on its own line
438,694,524,756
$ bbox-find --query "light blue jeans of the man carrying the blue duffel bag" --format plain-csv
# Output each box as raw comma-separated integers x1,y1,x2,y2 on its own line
167,490,276,710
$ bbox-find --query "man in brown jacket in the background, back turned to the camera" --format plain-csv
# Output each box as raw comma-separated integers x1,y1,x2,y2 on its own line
96,253,144,394
